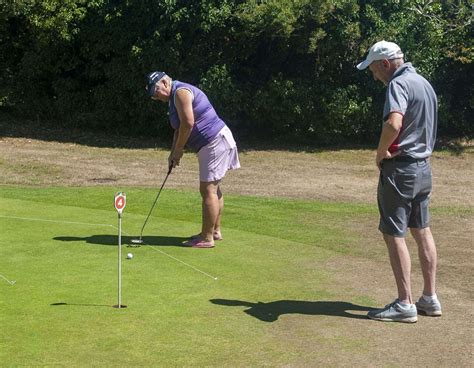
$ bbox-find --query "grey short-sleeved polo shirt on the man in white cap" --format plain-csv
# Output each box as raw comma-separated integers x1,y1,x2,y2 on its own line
383,63,438,159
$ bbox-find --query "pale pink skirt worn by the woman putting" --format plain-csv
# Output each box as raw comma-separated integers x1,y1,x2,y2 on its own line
197,126,240,183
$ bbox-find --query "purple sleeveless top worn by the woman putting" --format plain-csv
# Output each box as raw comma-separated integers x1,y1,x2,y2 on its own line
169,81,226,152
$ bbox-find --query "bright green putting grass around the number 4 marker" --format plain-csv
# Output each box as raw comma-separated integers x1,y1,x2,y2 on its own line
0,187,376,367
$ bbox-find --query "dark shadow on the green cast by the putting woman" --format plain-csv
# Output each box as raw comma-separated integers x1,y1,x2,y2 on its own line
53,234,188,247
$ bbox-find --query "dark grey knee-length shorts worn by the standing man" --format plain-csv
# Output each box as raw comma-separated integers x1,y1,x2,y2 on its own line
377,158,432,237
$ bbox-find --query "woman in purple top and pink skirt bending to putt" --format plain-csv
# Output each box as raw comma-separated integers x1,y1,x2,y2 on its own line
146,72,240,248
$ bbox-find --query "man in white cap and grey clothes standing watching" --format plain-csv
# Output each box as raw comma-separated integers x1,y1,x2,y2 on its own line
357,41,441,322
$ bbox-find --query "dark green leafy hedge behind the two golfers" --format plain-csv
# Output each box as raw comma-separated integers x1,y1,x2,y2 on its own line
0,0,474,145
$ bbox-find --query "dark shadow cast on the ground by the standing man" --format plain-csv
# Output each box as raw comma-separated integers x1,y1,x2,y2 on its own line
210,299,375,322
